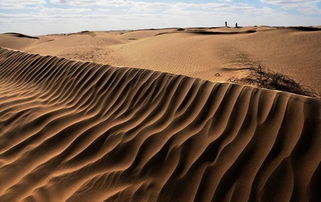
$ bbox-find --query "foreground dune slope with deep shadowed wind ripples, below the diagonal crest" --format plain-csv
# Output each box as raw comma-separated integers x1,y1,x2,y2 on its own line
0,49,321,202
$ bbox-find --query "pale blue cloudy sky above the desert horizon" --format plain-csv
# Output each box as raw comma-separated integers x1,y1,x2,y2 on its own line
0,0,321,35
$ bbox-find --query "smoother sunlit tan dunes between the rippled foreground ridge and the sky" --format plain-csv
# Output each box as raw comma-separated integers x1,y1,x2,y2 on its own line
0,27,321,94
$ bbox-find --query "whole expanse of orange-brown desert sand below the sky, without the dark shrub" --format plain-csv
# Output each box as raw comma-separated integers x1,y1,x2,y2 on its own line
0,27,321,202
